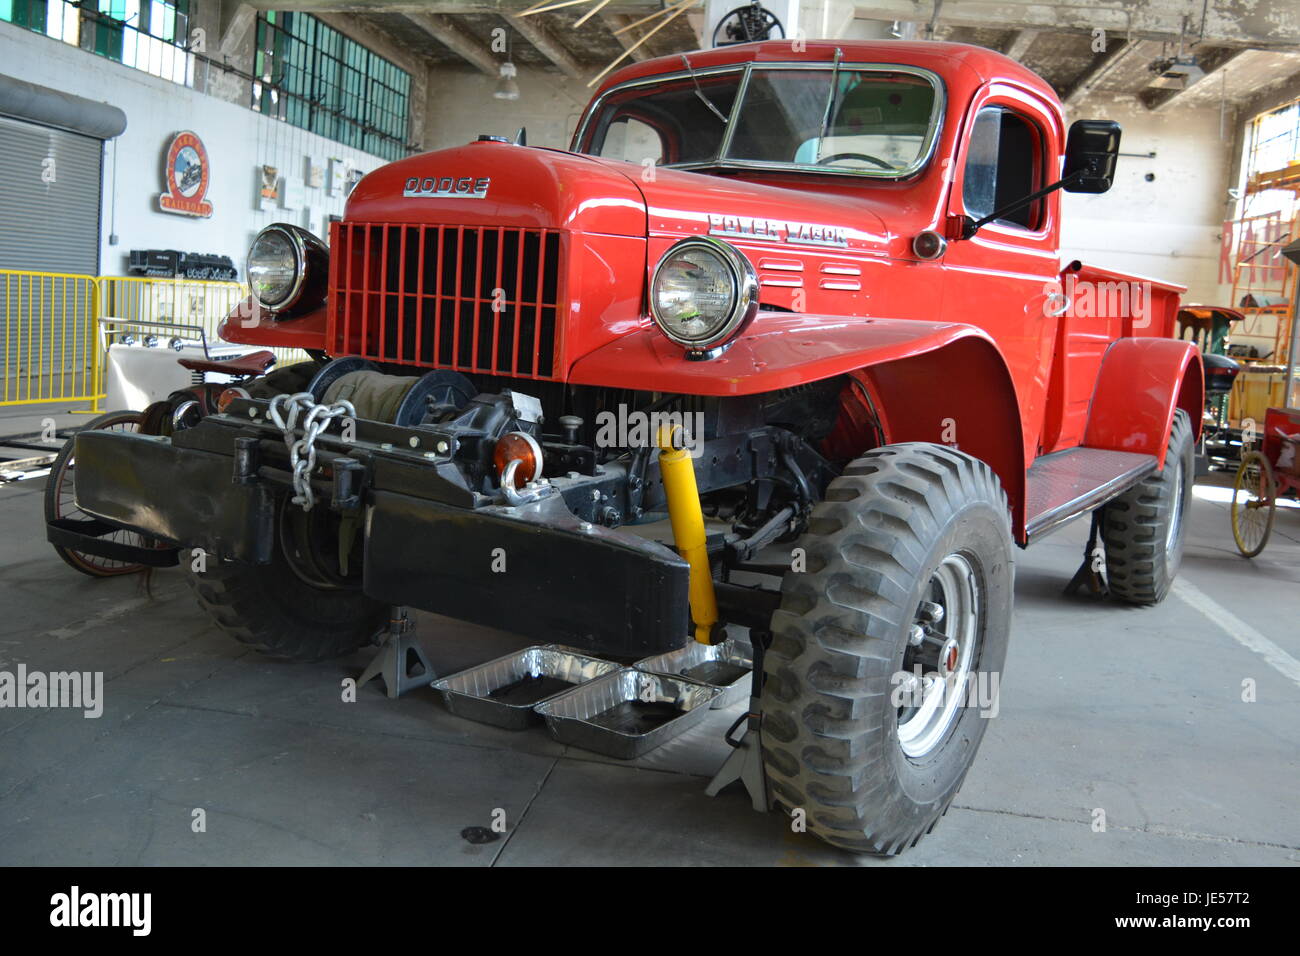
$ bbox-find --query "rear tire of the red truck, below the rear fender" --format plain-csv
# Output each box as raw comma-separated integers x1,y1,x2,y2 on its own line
1101,408,1196,605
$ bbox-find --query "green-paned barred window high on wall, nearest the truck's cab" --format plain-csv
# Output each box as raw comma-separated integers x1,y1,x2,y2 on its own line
253,11,411,160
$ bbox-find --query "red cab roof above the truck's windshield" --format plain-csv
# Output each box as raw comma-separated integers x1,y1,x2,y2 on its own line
597,40,1061,105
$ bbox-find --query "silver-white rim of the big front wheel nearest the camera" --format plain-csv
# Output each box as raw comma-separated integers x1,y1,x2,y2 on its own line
898,554,983,760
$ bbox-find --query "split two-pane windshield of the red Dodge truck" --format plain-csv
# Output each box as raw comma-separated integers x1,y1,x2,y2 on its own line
580,65,940,178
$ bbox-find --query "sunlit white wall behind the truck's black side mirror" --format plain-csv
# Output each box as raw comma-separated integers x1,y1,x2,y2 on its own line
1061,96,1235,304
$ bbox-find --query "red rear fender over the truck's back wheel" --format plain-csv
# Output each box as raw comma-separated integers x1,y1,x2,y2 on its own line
1083,338,1205,468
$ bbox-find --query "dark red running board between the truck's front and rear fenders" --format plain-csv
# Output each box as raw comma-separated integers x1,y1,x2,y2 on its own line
1024,449,1156,544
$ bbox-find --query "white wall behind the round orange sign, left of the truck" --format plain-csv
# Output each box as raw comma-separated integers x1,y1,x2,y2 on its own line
0,23,386,278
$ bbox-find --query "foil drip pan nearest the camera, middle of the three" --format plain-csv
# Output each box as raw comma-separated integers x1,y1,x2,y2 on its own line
536,667,722,760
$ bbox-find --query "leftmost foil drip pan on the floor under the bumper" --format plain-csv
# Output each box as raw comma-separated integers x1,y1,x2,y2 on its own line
433,644,619,730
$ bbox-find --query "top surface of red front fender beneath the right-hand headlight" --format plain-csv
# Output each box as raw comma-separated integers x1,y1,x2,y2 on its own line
568,312,988,395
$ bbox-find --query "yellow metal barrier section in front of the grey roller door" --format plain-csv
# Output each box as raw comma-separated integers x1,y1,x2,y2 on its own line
0,269,100,406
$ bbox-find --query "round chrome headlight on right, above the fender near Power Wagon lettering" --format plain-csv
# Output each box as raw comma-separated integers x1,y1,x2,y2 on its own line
650,237,758,358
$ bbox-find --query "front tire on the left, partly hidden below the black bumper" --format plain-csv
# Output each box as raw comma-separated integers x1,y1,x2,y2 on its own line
181,546,389,662
